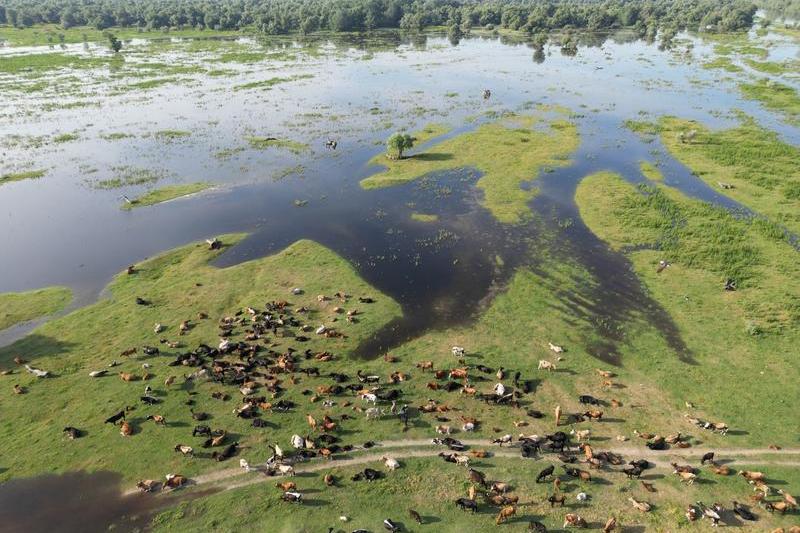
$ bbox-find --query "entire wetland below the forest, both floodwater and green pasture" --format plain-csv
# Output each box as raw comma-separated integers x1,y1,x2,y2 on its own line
0,8,800,531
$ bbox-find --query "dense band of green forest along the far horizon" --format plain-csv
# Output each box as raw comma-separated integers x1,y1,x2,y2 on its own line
0,0,756,34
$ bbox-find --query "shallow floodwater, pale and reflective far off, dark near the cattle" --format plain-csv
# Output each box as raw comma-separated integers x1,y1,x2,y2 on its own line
0,28,800,363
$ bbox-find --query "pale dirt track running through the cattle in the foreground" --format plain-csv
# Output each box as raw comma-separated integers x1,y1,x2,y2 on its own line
126,439,800,494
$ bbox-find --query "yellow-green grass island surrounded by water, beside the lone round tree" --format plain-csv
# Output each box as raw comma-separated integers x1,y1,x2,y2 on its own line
361,115,578,224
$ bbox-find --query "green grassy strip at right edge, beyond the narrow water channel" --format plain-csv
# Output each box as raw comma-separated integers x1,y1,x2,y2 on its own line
660,117,800,234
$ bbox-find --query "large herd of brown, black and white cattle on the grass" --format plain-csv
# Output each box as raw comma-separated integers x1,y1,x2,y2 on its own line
9,260,800,533
